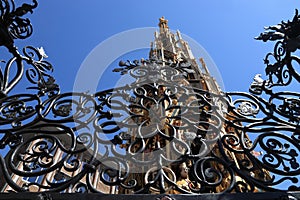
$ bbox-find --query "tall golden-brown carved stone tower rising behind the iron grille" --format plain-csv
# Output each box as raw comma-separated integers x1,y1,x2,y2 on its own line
112,17,267,194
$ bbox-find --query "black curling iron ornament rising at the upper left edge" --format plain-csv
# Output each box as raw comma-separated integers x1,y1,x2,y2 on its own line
0,0,58,96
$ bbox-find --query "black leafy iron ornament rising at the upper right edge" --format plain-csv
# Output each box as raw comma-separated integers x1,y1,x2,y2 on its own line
256,9,300,87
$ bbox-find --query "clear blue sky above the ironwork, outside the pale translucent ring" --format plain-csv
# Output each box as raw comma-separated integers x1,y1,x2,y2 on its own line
19,0,299,91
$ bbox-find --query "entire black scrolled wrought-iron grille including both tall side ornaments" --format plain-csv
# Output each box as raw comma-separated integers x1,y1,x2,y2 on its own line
0,0,300,194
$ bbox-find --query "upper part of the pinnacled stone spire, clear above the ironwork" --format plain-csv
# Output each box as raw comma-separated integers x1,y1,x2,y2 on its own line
149,16,220,93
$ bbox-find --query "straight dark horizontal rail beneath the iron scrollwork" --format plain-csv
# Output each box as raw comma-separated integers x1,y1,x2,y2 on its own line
0,192,300,200
